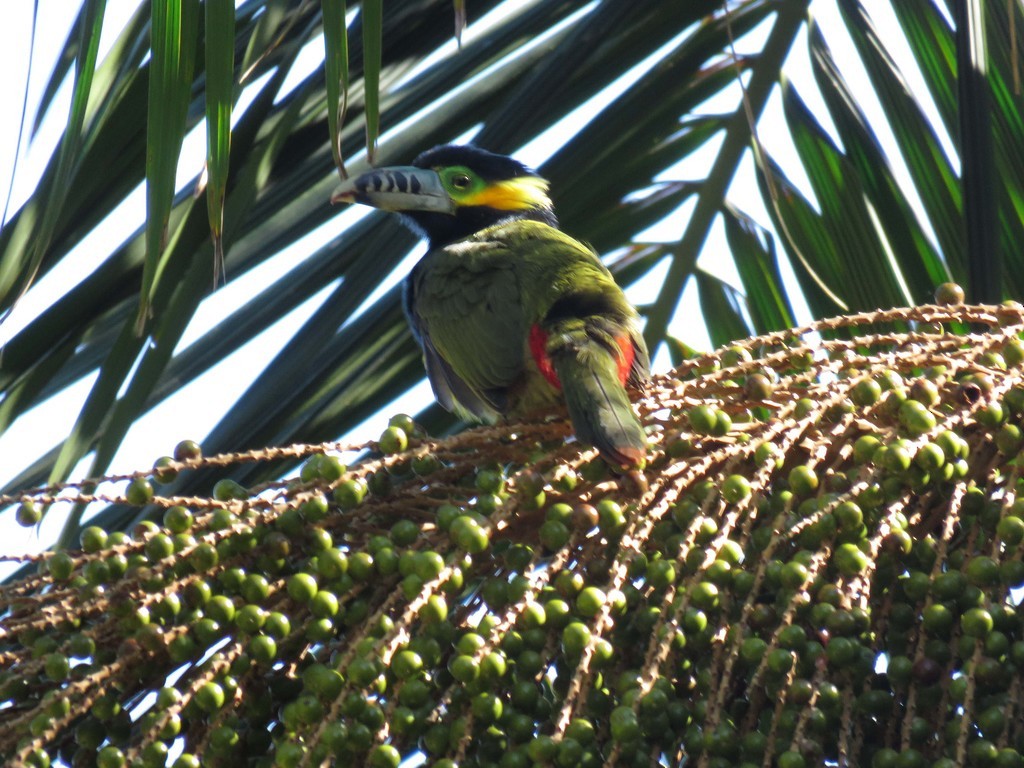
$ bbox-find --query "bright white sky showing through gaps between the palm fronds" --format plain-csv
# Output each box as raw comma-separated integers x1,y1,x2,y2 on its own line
0,0,952,574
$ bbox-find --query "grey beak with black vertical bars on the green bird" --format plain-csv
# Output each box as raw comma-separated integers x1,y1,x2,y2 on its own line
331,166,455,214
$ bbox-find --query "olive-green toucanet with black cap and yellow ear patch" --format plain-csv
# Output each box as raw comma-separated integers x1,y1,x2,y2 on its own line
331,144,650,473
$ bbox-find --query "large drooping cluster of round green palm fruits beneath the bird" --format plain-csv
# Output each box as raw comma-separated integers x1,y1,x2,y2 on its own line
0,305,1024,768
